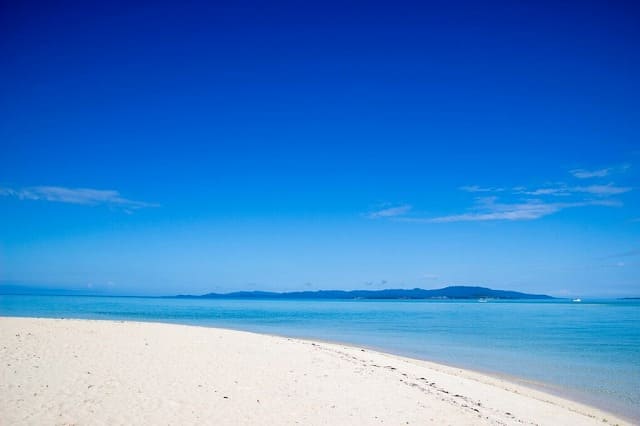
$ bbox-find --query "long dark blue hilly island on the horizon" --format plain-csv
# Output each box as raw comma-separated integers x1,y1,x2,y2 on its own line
173,286,554,300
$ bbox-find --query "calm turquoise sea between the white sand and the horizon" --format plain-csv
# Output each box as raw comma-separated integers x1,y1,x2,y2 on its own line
0,295,640,420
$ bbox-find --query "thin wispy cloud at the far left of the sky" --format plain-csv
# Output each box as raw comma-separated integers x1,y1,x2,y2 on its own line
0,186,158,211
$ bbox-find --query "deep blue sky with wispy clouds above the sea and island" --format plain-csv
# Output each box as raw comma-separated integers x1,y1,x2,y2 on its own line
0,1,640,296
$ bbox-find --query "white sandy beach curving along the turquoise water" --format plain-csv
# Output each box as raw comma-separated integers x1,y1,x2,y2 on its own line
0,317,628,425
